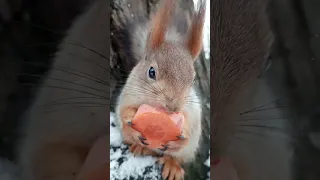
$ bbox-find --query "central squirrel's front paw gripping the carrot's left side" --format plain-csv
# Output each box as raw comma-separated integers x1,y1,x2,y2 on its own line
122,121,149,145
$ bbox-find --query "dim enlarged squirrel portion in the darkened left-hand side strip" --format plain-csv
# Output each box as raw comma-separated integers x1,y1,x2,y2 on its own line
17,0,110,180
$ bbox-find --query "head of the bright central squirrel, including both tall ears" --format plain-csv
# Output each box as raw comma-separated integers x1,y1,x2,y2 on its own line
129,0,206,112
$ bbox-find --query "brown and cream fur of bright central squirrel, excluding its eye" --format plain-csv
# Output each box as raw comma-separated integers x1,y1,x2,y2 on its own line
116,0,204,180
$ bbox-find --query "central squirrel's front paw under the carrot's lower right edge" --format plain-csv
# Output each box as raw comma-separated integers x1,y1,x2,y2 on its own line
159,133,189,152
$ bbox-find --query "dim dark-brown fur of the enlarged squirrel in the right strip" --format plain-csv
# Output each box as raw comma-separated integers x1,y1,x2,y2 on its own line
211,0,270,159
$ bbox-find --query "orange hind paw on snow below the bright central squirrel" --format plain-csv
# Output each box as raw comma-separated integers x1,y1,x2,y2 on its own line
158,155,184,180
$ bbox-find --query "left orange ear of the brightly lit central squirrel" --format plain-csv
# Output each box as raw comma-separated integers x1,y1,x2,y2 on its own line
147,0,176,50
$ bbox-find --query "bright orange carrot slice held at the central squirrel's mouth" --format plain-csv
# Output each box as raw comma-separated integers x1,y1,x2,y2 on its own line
132,104,184,148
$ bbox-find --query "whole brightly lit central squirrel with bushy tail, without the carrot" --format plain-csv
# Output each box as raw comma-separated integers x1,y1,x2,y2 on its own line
113,0,206,180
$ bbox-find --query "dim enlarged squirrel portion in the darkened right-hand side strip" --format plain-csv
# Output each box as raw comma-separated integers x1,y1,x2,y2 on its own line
210,0,291,180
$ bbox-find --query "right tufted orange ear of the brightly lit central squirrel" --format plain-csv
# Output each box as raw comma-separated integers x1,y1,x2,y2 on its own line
187,0,206,59
